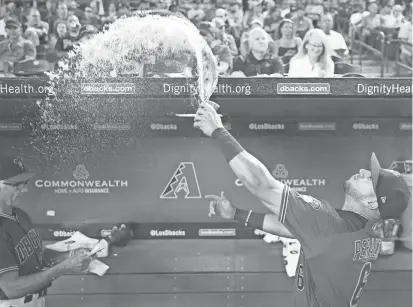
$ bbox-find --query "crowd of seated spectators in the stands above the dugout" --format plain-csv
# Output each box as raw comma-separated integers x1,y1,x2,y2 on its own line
0,0,412,78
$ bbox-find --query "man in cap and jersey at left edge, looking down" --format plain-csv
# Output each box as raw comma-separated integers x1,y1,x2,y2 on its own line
0,157,127,307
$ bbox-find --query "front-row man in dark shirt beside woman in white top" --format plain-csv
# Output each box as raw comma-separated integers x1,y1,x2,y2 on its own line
231,28,284,77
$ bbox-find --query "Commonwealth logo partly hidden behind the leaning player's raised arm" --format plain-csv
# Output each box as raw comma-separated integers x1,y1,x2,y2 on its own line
235,164,327,193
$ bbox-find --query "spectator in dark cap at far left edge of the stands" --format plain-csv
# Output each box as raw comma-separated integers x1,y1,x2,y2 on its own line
0,19,36,72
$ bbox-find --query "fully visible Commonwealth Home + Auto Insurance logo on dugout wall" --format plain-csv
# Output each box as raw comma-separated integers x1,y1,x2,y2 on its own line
34,164,128,194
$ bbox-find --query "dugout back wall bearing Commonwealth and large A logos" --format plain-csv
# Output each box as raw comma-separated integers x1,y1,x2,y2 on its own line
0,134,412,238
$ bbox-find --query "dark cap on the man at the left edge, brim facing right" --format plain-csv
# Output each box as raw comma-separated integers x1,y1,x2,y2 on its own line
0,156,35,183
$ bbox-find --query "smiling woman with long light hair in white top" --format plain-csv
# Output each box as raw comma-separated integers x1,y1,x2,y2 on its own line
288,29,334,78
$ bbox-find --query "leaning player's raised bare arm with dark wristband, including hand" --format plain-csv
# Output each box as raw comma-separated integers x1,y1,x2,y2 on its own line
194,102,285,216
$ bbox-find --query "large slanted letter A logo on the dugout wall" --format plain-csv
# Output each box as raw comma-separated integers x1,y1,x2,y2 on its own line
161,162,202,199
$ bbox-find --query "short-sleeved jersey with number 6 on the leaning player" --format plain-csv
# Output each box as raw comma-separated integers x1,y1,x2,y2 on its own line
280,186,381,307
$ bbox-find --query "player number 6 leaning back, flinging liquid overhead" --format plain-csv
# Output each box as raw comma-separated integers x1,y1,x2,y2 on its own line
194,103,410,307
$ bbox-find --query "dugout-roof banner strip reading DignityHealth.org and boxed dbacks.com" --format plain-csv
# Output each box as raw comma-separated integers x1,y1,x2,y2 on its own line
0,78,413,98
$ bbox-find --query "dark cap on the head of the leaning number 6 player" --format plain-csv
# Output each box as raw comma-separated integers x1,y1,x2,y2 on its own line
370,153,411,219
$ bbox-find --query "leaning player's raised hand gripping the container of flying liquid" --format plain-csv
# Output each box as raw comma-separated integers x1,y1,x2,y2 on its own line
194,102,224,137
